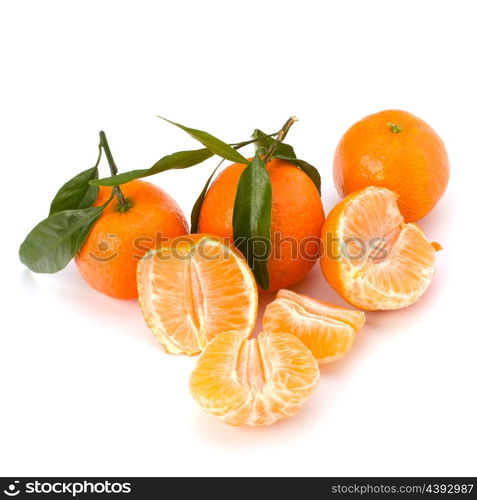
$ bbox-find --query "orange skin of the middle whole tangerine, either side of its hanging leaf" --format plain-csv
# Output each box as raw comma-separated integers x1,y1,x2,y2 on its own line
199,159,325,291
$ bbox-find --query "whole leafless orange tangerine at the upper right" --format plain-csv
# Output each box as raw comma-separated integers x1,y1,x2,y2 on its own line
333,110,449,222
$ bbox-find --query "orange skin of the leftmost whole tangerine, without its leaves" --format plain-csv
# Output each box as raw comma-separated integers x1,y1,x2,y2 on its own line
76,180,188,299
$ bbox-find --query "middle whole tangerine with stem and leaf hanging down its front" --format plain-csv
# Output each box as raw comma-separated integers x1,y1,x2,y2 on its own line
198,118,325,291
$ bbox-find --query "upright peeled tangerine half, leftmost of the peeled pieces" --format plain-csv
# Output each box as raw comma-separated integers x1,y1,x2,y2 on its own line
137,234,258,355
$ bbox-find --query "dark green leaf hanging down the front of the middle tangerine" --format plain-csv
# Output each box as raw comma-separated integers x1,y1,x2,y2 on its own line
232,152,272,290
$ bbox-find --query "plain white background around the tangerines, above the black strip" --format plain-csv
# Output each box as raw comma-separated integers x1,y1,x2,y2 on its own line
0,0,477,476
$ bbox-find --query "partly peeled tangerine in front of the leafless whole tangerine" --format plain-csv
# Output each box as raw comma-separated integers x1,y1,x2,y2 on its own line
321,186,436,310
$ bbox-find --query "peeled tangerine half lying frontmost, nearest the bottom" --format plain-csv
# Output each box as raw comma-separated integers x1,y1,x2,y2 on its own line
190,332,319,426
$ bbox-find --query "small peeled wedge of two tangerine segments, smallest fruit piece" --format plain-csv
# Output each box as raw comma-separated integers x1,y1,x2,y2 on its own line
263,290,366,363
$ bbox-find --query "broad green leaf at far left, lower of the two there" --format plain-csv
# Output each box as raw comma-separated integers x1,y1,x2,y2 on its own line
19,205,104,273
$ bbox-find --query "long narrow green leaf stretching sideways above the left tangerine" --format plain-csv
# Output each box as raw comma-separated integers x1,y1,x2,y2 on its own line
90,148,214,186
